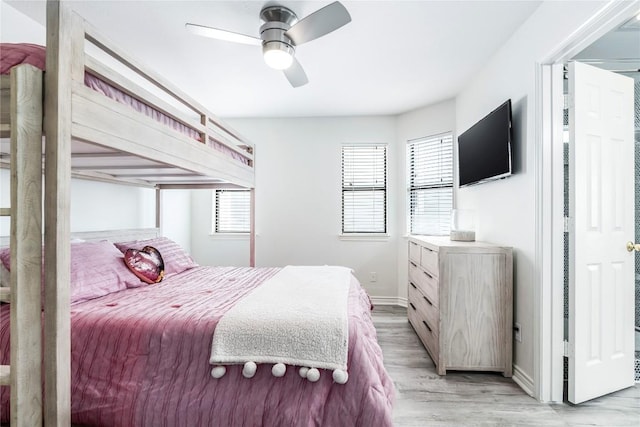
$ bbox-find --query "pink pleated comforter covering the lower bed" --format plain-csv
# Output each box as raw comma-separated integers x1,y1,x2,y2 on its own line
0,267,394,427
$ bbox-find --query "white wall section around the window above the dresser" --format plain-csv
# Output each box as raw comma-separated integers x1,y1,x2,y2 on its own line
395,100,456,301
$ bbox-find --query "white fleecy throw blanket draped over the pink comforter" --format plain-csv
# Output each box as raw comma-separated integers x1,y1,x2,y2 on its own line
209,266,351,371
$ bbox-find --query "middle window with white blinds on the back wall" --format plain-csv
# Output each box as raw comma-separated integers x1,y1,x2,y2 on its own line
342,145,387,234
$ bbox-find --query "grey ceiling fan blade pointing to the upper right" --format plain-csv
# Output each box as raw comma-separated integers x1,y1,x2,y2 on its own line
284,1,351,45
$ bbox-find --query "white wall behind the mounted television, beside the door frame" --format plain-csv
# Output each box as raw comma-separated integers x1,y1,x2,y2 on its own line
456,1,604,393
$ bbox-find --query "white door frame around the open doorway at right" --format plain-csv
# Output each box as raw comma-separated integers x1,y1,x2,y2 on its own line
533,1,640,402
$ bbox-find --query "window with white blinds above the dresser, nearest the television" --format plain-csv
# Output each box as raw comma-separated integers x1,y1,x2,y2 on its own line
407,133,453,235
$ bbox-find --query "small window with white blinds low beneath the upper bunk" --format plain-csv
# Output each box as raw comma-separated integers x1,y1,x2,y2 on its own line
214,190,251,233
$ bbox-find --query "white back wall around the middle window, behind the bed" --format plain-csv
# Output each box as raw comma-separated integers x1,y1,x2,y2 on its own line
191,117,400,298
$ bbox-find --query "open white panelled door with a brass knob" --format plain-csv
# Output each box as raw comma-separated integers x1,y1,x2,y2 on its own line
569,63,635,403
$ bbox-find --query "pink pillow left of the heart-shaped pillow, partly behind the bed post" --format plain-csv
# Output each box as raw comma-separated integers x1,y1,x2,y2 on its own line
0,240,139,304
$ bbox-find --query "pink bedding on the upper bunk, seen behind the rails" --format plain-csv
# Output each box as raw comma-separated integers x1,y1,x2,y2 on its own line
0,43,249,164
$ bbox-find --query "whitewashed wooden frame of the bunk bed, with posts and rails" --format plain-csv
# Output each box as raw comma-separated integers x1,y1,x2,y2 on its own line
0,0,255,426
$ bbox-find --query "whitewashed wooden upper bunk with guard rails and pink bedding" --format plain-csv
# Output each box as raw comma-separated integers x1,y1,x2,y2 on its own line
0,2,254,189
